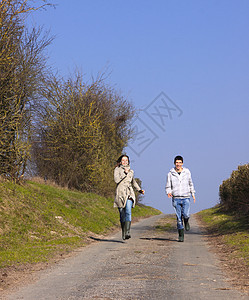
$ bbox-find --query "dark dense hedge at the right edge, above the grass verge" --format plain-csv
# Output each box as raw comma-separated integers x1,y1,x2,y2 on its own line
219,164,249,215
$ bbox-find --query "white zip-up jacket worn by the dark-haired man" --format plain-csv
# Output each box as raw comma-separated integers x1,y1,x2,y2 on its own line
166,168,195,198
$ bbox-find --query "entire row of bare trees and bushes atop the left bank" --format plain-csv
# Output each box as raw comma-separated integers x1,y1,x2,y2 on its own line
0,0,135,196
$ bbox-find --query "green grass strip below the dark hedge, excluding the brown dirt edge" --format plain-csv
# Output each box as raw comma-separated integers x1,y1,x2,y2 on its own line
197,206,249,266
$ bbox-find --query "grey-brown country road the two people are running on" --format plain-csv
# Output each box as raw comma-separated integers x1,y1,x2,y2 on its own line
4,215,248,300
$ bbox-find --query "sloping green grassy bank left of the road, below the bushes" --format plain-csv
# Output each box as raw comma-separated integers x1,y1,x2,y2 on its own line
0,181,160,268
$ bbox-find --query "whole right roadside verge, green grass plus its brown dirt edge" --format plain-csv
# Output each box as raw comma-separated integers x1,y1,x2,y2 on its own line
196,206,249,293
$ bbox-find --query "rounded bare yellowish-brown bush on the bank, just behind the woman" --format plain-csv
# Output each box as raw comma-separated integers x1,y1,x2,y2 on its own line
33,74,134,196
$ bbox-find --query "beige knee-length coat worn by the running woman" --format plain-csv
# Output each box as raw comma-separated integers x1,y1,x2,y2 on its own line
114,166,141,208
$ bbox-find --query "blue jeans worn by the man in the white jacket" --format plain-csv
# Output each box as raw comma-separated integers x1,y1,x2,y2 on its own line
172,198,190,229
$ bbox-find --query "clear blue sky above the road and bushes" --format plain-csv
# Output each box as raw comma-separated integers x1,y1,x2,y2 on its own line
28,0,249,213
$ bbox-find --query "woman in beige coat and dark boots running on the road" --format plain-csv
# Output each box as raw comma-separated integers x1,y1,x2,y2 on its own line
114,155,144,240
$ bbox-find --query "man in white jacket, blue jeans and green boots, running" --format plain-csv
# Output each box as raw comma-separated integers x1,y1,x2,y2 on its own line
166,155,195,242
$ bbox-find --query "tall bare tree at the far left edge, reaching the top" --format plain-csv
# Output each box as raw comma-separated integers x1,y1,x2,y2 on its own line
0,0,51,181
